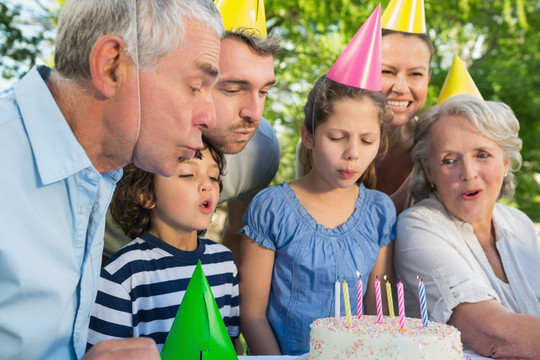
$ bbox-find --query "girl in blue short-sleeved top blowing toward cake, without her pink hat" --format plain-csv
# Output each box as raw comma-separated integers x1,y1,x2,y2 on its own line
239,76,396,355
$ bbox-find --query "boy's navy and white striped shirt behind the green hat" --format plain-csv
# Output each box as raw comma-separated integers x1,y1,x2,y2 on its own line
87,233,240,351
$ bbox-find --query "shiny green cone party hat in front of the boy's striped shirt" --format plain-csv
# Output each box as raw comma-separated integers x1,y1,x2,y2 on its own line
161,260,238,360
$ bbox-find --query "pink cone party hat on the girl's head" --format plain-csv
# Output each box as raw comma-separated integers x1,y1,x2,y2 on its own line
326,4,382,91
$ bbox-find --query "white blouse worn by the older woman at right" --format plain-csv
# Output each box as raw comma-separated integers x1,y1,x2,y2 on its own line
394,196,540,323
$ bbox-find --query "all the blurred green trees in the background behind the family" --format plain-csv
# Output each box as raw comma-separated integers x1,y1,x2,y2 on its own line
0,0,540,222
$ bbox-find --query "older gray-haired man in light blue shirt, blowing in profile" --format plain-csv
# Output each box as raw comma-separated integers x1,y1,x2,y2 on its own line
0,0,224,359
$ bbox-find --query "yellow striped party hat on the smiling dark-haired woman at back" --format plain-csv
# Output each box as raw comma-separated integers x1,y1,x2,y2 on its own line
381,0,426,34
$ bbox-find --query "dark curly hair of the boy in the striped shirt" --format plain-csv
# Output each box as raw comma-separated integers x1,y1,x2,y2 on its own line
110,139,225,239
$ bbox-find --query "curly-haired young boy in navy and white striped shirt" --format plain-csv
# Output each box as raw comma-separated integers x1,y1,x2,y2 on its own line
87,143,239,351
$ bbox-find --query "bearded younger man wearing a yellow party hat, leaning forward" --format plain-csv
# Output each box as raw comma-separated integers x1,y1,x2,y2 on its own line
104,0,280,261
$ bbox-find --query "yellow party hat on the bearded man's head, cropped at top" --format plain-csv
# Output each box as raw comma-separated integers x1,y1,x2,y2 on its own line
215,0,267,38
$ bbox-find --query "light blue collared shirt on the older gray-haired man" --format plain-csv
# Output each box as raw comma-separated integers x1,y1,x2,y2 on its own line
0,67,122,359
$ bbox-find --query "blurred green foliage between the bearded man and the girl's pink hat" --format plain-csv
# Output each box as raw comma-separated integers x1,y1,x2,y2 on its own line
265,0,378,184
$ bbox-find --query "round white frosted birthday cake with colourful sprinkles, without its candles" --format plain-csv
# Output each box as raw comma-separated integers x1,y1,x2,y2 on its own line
309,315,463,360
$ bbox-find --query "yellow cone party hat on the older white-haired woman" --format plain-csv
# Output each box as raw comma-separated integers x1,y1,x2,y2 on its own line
437,55,483,105
